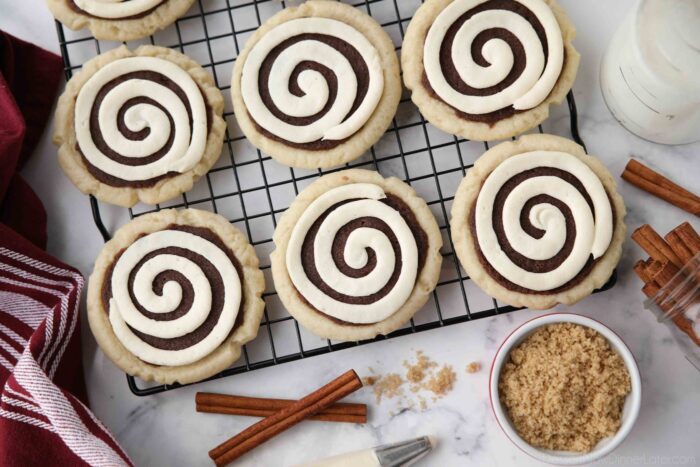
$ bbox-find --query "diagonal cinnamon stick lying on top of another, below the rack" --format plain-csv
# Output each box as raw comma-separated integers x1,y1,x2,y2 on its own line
209,370,362,466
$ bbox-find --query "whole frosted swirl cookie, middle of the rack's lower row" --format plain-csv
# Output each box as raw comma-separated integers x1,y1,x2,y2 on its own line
270,169,442,341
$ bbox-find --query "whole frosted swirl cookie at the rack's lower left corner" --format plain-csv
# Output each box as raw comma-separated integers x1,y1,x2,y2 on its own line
87,209,265,384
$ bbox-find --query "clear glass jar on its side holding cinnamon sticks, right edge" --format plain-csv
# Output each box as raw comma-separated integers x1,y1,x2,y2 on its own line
644,253,700,371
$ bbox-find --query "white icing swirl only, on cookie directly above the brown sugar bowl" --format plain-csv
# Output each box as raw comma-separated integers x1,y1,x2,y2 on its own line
475,151,613,291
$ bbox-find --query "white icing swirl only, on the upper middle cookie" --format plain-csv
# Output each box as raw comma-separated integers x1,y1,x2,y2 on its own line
241,17,384,143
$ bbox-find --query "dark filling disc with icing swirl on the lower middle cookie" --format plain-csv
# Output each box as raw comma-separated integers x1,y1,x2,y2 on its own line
286,183,428,324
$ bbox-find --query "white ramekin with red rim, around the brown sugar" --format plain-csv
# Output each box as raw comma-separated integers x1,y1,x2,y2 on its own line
489,313,642,465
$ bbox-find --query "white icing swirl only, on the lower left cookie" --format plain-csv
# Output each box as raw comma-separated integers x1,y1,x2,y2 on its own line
109,230,242,366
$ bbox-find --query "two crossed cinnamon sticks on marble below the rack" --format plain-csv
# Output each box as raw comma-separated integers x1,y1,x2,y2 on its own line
200,370,367,466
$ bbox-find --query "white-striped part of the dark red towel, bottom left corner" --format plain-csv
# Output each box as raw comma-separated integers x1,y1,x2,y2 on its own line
0,224,130,466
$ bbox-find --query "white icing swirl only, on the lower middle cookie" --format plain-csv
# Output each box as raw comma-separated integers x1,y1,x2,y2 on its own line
286,183,418,324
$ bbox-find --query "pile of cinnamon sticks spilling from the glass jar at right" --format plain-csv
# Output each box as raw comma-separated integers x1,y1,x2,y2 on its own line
632,222,700,345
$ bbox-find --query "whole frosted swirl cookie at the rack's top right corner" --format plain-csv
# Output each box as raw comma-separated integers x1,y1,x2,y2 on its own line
401,0,580,141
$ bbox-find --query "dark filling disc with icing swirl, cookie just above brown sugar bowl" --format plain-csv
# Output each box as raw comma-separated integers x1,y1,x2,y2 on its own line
471,151,614,293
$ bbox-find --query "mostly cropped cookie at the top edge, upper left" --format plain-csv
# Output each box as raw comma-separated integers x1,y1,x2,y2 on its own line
46,0,194,41
